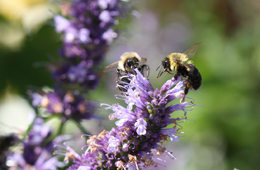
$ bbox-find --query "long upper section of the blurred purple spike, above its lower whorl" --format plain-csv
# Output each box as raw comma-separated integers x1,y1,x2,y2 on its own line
53,0,124,89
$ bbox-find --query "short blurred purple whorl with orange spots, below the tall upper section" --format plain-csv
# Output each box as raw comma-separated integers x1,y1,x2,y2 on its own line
31,90,96,121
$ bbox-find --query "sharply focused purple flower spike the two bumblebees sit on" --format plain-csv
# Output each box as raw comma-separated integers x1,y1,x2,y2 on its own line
66,70,194,170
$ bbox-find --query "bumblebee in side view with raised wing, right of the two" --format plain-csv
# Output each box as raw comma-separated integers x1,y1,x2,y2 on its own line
157,43,202,95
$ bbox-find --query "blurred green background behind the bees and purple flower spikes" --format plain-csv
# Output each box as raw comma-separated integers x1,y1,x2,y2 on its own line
0,0,260,170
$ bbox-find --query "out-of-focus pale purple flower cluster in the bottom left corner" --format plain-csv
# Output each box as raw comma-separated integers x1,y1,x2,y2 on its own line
7,118,63,170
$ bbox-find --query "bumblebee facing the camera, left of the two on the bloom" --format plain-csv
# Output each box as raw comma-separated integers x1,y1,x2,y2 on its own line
103,52,150,94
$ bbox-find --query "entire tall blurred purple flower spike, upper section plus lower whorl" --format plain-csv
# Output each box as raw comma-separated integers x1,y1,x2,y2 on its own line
35,0,131,125
